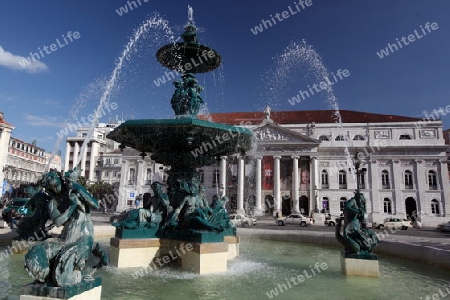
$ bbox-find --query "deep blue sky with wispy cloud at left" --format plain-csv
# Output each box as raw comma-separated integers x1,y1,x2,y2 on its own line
0,0,450,155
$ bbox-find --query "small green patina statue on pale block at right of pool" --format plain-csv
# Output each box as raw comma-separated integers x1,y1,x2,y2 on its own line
336,190,380,259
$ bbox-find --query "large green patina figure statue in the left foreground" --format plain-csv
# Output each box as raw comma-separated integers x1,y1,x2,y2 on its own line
21,168,108,287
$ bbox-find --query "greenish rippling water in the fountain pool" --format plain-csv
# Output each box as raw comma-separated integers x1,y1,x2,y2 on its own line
0,239,450,300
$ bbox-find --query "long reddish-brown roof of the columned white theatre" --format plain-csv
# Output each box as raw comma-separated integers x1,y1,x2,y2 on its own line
199,110,422,125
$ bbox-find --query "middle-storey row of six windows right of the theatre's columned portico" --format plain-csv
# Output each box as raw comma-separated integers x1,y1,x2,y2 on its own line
321,170,438,190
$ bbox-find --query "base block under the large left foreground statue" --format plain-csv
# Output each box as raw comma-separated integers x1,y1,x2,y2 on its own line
19,278,102,300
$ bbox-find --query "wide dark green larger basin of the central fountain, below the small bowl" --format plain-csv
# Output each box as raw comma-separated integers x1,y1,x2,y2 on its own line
107,117,253,167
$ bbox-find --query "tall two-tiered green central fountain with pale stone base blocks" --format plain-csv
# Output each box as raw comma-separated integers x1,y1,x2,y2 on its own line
107,7,253,273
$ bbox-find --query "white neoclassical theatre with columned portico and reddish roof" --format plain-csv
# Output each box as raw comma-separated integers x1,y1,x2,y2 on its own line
67,110,450,226
